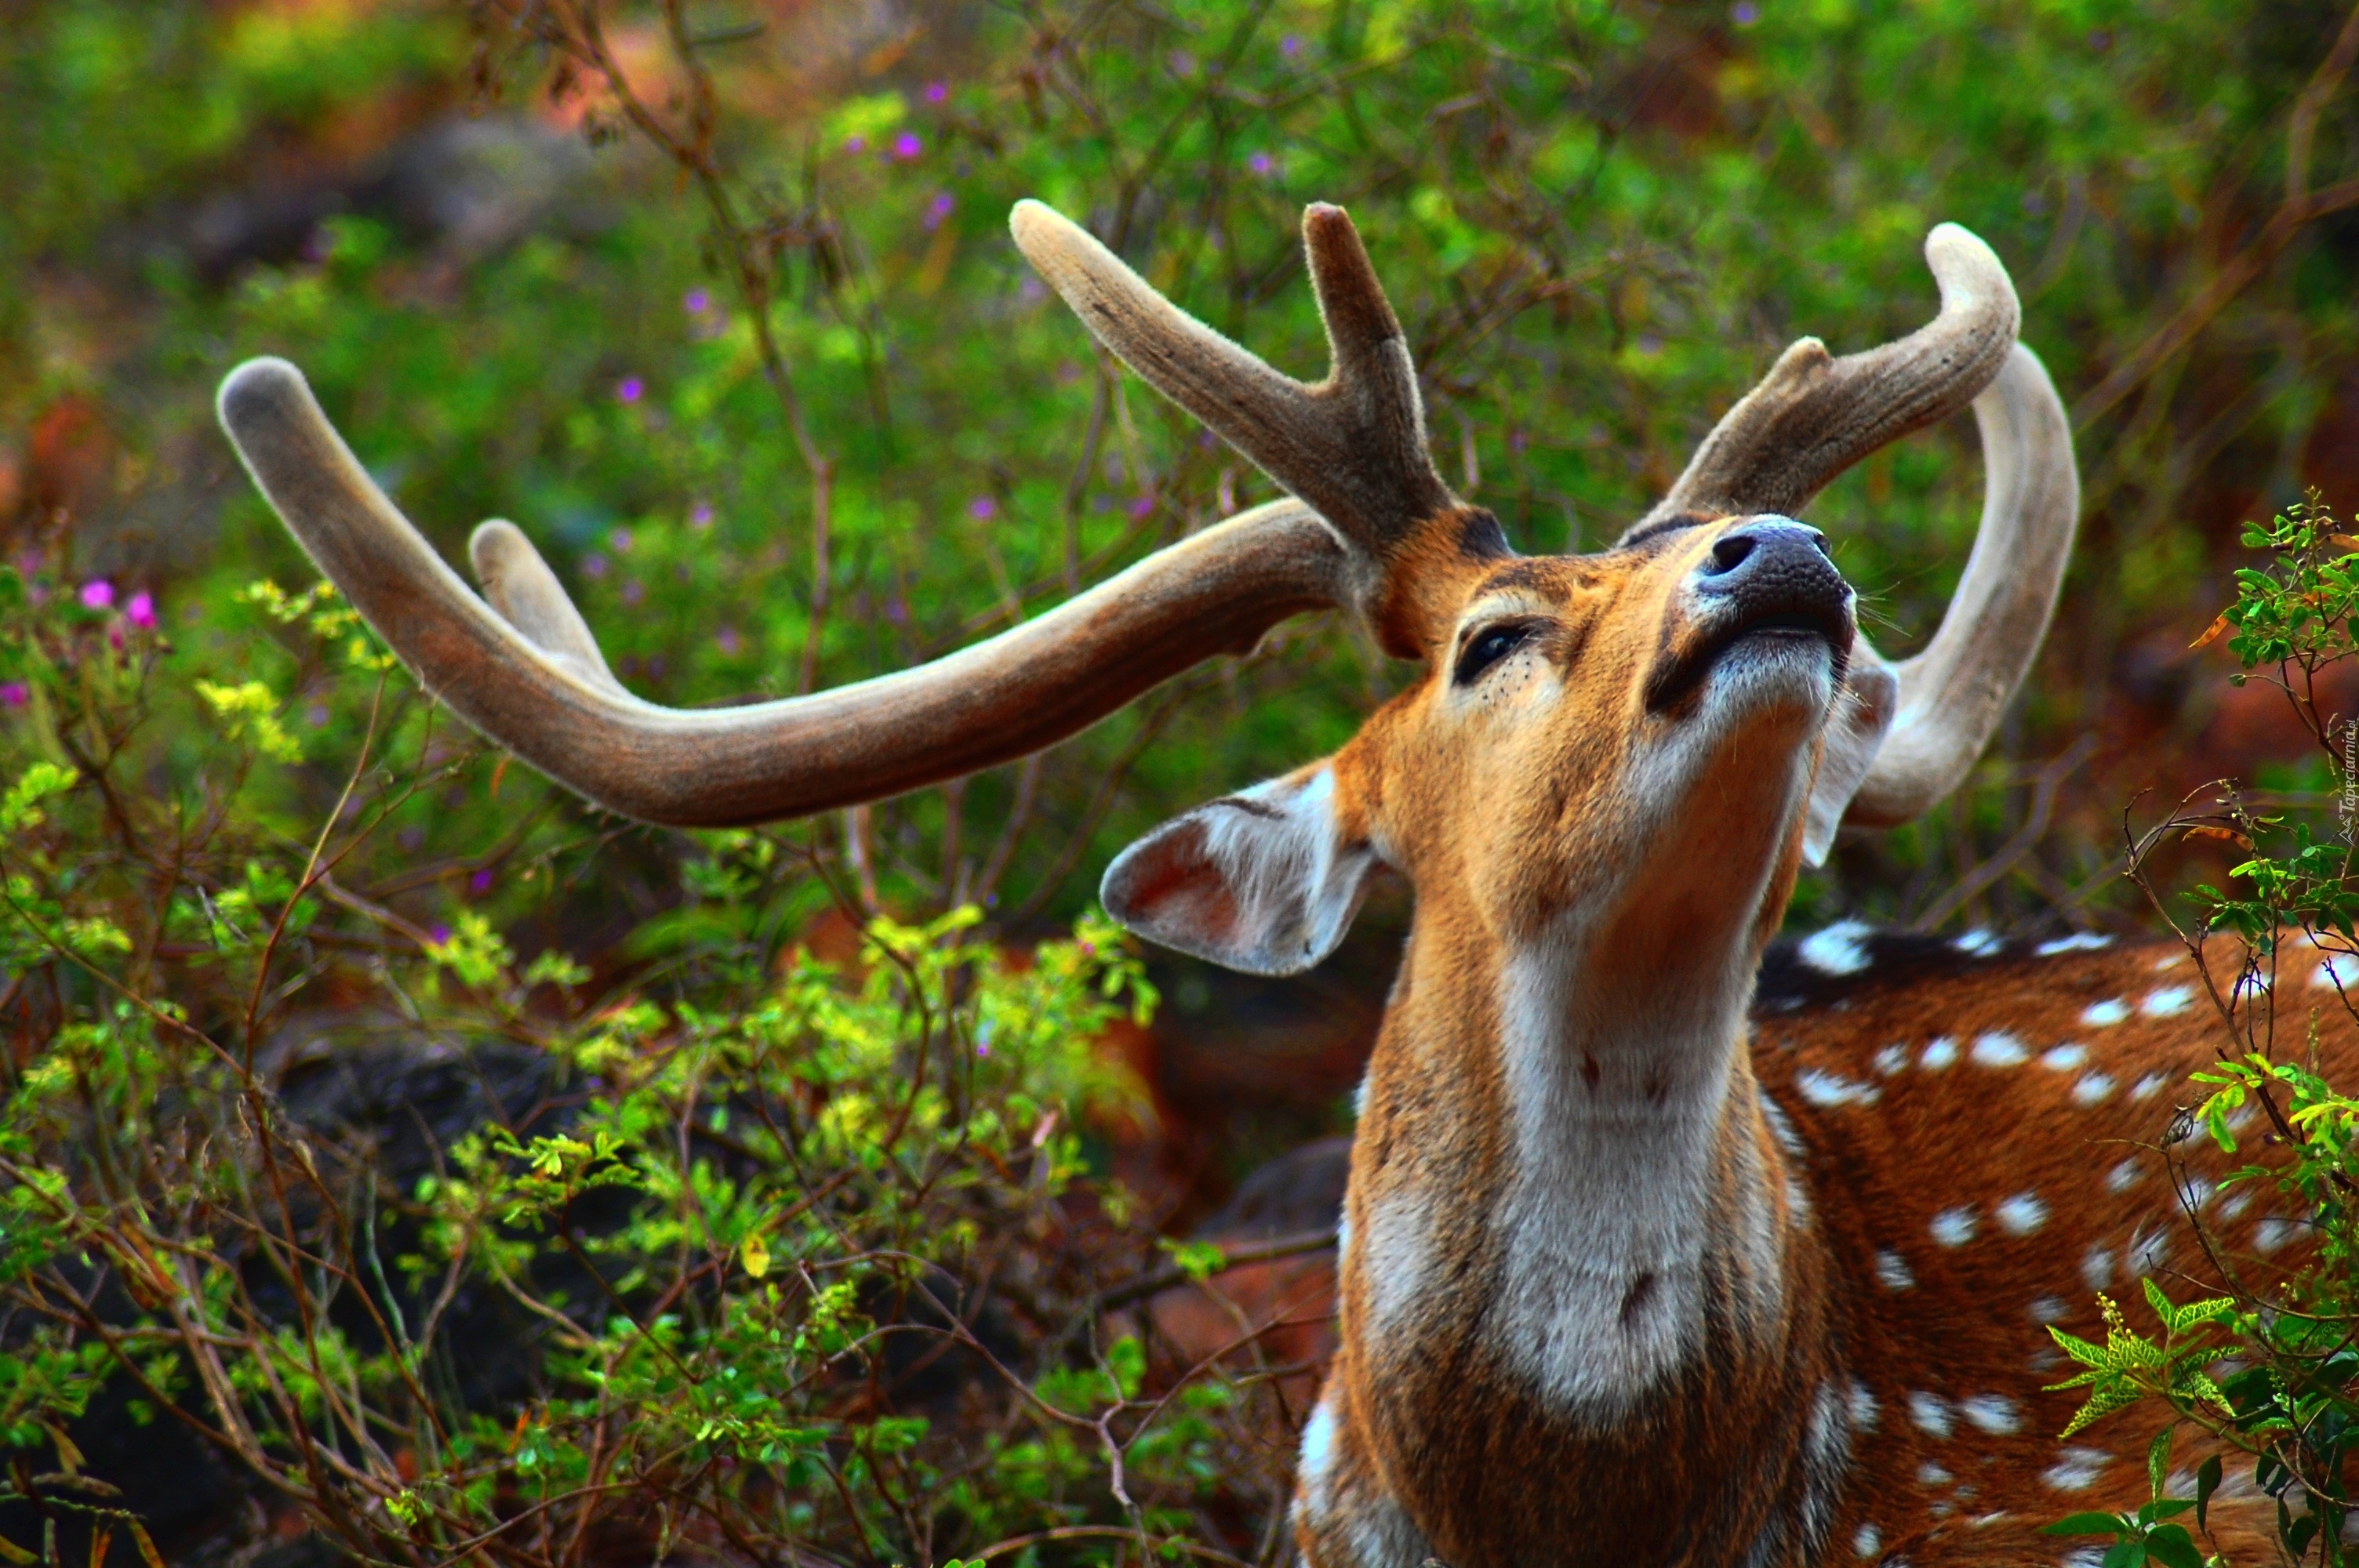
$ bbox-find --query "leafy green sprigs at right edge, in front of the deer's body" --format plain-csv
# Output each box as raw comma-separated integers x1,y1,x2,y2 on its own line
2095,495,2359,1566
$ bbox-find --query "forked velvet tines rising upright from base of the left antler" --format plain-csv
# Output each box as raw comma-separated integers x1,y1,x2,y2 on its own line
1009,201,1456,572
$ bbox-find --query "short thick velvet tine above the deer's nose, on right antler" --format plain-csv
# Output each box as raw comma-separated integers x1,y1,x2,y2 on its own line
1633,224,2022,533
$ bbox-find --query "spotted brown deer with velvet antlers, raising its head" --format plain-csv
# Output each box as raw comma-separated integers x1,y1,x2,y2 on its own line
220,203,2339,1568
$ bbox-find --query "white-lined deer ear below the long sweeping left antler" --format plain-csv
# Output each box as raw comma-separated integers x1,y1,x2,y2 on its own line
1100,761,1378,974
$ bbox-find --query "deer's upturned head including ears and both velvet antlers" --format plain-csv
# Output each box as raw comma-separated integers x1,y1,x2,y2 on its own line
220,203,2074,943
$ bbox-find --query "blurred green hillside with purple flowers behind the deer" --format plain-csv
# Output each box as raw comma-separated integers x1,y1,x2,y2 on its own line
13,0,2359,1330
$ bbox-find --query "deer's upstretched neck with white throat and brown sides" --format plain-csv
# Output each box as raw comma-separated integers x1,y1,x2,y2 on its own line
1345,820,1856,1563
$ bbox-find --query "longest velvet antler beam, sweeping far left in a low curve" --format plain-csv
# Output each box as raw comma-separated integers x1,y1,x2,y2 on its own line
220,358,1350,828
